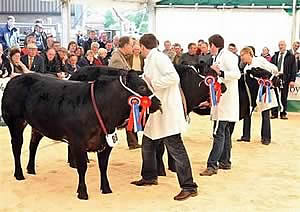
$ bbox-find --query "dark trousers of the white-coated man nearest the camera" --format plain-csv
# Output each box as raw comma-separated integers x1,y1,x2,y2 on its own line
141,134,198,191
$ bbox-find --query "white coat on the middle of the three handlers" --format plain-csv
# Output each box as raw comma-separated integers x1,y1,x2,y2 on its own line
211,49,241,122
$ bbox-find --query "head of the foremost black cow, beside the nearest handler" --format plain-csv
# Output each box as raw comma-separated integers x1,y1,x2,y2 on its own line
126,71,161,113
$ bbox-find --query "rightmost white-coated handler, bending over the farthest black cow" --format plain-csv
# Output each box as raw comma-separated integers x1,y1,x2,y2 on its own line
237,47,278,145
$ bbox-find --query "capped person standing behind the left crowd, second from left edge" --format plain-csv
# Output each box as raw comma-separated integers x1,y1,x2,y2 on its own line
28,19,47,52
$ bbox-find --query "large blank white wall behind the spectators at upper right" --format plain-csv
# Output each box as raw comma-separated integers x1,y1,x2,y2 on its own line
156,8,292,54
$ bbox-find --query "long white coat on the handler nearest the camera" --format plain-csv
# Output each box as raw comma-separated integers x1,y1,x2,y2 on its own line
144,48,186,140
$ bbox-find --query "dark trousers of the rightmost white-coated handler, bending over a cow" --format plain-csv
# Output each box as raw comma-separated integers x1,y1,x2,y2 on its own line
242,110,271,140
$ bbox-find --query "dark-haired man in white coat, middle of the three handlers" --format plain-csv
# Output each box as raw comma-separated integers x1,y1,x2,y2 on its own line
200,34,241,176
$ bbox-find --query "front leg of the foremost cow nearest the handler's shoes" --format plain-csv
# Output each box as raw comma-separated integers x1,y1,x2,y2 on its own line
97,143,112,194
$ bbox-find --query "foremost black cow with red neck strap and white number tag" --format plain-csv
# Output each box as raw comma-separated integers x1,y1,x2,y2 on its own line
2,68,160,199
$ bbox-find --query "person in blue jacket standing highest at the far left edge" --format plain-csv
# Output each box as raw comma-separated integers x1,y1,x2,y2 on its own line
0,16,19,52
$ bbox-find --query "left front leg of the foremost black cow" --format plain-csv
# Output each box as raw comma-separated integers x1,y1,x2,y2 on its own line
70,144,88,200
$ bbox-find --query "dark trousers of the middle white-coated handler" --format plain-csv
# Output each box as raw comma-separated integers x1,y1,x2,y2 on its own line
207,121,235,169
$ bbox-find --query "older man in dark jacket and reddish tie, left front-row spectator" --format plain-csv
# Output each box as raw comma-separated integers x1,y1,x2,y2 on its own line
21,43,45,73
